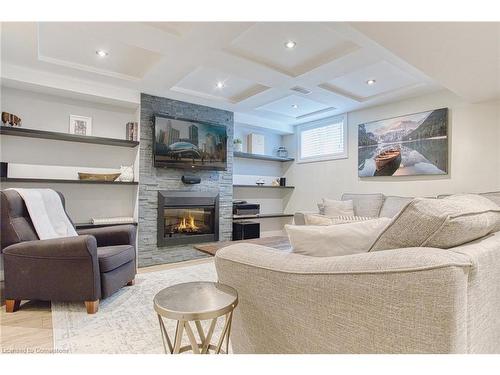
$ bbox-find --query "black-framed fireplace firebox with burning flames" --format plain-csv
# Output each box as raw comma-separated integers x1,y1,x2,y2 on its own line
158,190,219,246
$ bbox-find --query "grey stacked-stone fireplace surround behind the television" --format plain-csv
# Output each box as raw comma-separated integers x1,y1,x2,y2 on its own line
138,94,234,267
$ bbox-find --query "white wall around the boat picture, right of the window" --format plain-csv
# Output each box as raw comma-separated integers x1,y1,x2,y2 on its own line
285,91,500,212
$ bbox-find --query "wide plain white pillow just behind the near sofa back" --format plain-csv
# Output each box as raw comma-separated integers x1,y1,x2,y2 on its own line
285,217,391,257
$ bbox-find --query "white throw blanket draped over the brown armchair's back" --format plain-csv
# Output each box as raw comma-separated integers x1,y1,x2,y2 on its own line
12,189,78,240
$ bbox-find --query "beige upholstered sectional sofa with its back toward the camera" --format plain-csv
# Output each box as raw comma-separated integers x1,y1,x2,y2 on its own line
215,192,500,353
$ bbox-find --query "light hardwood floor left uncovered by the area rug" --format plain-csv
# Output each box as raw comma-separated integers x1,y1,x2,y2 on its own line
0,258,213,354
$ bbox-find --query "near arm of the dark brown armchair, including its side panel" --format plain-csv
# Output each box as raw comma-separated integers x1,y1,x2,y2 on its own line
3,236,101,301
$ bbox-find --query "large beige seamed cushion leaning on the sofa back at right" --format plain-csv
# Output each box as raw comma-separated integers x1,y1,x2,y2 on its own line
370,194,500,251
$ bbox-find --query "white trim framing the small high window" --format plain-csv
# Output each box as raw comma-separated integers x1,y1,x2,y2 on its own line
295,113,349,164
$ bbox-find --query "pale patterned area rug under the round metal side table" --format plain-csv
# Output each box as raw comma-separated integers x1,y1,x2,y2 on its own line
52,261,224,354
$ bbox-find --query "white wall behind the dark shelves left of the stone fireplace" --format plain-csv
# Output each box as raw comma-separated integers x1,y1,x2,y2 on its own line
0,87,138,222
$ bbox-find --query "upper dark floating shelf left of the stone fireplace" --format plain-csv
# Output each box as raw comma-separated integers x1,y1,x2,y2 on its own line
0,126,139,147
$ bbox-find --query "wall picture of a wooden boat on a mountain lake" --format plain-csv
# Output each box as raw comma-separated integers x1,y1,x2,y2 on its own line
358,108,448,177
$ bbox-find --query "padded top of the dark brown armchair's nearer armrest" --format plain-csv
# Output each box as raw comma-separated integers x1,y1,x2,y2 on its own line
3,236,97,259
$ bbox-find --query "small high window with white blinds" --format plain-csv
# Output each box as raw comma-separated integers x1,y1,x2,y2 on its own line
298,116,347,162
